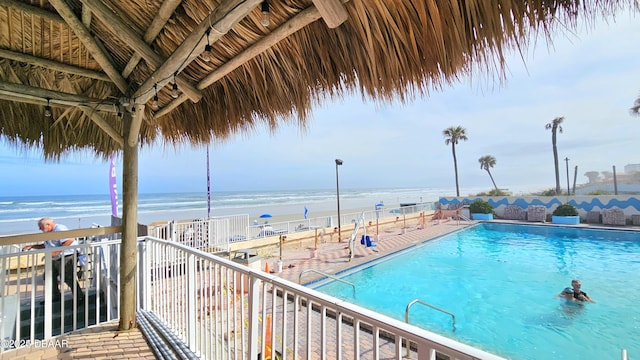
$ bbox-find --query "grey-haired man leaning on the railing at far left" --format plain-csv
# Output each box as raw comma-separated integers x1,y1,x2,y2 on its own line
22,217,84,303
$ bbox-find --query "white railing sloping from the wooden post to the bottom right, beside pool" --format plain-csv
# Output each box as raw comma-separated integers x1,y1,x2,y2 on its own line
139,237,501,360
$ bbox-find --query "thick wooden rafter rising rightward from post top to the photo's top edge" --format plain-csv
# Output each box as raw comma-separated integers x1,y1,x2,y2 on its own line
133,0,262,103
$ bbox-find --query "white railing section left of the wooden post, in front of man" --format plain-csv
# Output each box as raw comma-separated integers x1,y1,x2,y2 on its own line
0,238,120,352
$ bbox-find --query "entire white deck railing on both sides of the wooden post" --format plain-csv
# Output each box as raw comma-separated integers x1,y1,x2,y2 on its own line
0,222,508,359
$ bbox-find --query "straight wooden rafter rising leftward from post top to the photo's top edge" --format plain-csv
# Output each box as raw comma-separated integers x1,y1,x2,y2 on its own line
49,0,128,94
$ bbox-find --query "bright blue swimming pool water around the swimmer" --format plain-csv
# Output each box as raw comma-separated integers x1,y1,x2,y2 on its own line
317,223,640,359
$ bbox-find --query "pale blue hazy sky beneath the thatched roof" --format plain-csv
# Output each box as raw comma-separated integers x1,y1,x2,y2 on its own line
0,14,640,196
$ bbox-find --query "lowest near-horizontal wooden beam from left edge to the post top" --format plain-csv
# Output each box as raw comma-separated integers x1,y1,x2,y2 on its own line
0,81,117,113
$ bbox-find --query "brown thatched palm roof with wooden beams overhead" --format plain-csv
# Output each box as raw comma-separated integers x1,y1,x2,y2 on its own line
0,0,634,159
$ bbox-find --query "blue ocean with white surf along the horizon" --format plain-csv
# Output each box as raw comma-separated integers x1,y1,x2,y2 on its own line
0,188,482,235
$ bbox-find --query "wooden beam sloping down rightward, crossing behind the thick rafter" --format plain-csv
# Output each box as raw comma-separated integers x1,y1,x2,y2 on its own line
81,0,202,102
